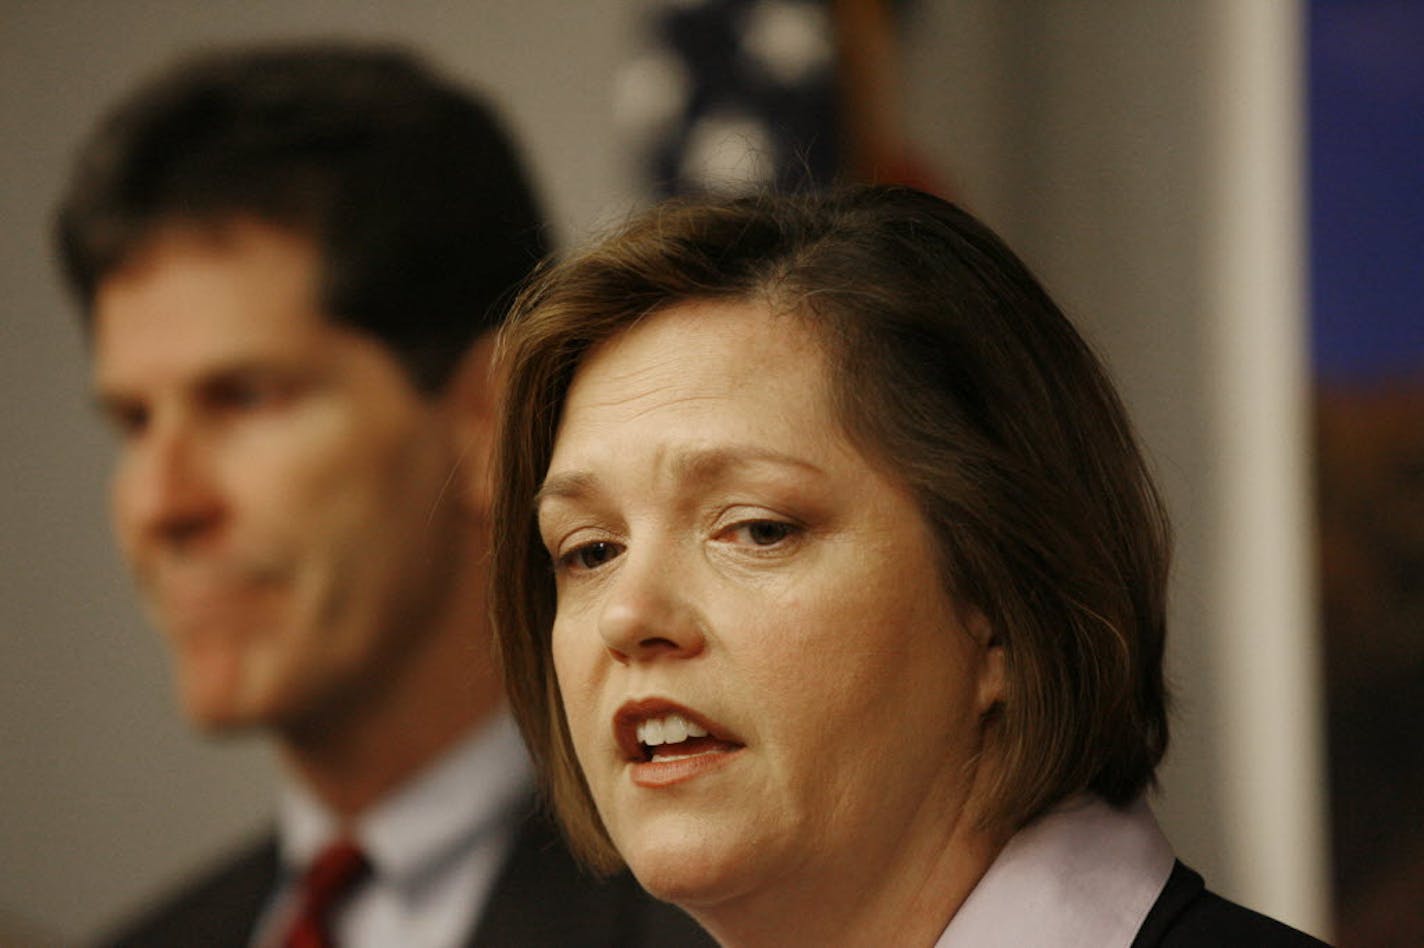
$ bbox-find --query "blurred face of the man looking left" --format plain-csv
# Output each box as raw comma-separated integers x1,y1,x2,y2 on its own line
94,221,468,730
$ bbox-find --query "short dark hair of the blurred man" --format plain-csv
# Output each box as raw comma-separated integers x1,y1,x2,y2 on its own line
57,43,548,391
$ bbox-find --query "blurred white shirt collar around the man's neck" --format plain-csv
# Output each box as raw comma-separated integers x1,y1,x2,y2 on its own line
278,713,533,885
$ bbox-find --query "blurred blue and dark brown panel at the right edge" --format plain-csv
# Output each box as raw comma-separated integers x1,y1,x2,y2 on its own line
1307,0,1424,945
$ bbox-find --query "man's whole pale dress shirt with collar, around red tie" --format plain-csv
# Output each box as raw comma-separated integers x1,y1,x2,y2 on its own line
253,715,533,948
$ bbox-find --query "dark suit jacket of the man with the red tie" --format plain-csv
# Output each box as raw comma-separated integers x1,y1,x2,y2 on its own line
100,809,713,948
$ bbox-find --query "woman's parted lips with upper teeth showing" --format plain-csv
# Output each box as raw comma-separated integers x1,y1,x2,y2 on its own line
614,697,743,787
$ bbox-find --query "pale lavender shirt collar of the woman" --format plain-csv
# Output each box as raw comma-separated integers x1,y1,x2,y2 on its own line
936,796,1175,948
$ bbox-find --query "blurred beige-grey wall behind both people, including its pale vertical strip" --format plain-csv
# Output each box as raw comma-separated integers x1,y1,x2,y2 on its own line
0,0,1331,941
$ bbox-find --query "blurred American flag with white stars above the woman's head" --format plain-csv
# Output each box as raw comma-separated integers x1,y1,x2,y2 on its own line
614,0,927,196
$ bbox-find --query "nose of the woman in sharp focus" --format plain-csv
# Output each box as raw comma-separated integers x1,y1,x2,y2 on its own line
598,549,705,665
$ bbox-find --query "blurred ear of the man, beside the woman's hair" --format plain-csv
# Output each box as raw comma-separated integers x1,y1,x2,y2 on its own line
441,333,500,521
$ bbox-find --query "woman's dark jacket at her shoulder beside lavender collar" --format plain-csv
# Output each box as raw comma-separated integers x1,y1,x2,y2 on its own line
1132,863,1324,948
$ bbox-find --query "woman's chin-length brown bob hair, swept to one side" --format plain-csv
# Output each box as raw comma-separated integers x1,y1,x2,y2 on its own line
491,186,1171,871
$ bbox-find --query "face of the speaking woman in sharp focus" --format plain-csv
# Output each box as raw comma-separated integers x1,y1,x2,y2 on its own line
538,302,1001,917
